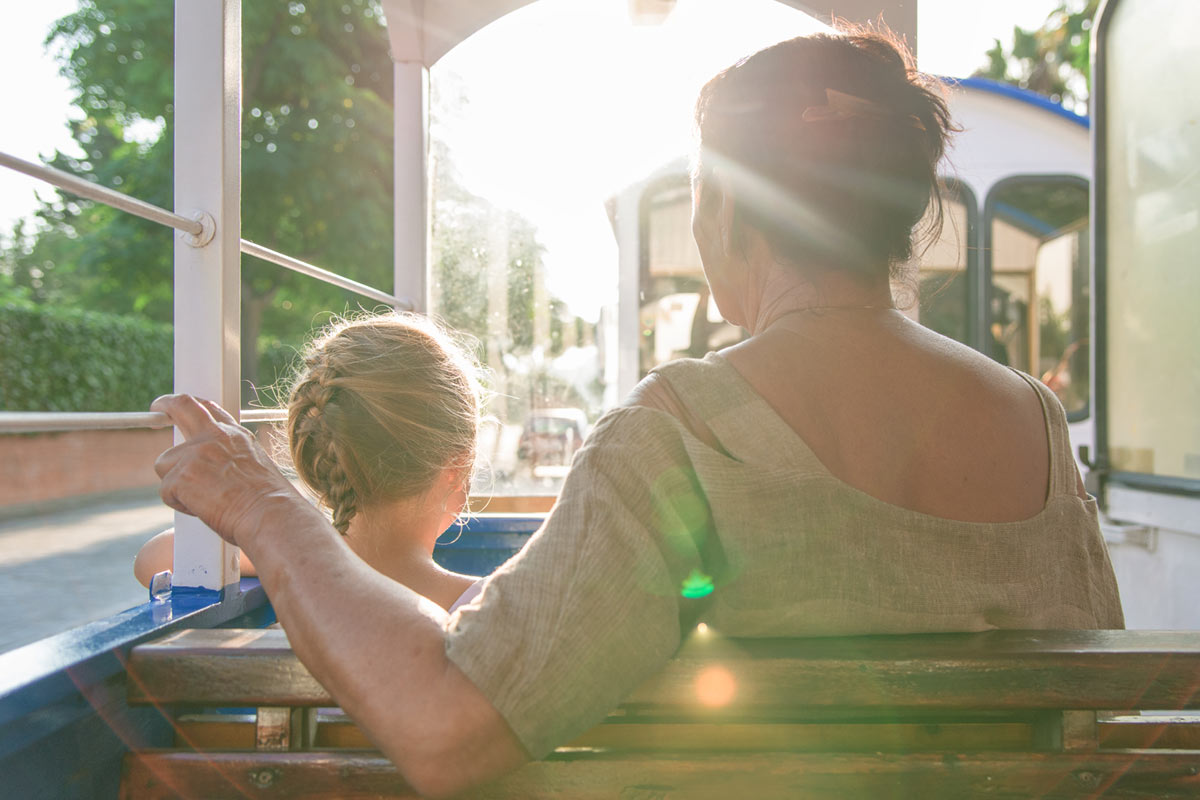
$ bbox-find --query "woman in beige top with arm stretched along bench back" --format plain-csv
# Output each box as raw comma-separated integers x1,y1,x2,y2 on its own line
157,31,1122,794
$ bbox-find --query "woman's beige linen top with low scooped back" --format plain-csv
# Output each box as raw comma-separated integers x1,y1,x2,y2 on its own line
446,354,1123,758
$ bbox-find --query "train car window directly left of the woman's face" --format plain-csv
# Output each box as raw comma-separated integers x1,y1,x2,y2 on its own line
638,175,745,375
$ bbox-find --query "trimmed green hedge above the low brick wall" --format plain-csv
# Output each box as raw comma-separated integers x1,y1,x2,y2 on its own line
0,301,173,411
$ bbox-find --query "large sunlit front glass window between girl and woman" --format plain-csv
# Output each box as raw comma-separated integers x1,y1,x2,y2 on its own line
430,0,822,494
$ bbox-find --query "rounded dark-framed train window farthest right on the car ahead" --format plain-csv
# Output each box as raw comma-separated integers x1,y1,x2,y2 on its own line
984,175,1091,420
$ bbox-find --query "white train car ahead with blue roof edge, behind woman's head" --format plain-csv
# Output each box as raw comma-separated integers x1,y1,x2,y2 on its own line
610,78,1092,455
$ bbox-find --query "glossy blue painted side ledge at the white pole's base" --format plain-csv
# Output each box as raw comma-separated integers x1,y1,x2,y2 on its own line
0,578,274,726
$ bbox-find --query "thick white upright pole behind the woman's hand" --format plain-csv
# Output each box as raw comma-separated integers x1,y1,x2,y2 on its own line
172,0,241,589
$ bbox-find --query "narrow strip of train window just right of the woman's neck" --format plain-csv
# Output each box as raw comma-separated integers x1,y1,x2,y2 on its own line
912,181,978,344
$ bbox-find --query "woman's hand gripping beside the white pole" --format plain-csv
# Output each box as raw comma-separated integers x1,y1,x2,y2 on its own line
150,395,314,547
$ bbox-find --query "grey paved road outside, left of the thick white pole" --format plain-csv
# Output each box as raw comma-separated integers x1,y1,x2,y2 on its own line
0,495,172,652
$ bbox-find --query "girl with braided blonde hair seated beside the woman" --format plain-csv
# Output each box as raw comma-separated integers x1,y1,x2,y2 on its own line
141,313,492,610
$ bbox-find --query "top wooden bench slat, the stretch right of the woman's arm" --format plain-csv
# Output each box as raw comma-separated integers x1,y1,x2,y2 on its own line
626,631,1200,710
